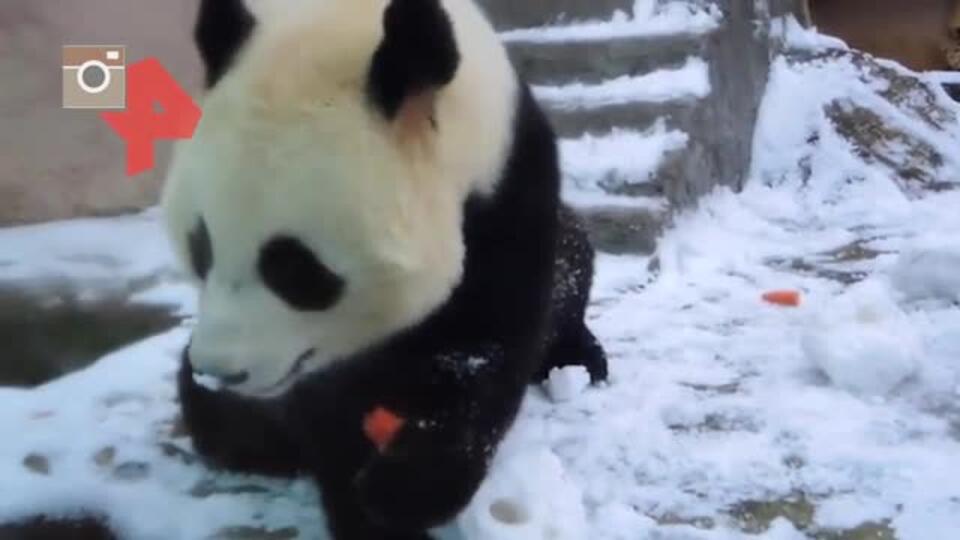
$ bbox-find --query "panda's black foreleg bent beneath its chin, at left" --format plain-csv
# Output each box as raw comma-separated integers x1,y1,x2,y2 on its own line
177,354,302,476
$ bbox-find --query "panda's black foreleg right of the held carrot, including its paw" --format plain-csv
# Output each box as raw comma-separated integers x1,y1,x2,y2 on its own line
342,345,529,532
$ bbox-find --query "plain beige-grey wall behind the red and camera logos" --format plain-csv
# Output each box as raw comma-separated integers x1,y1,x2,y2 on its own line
0,0,200,224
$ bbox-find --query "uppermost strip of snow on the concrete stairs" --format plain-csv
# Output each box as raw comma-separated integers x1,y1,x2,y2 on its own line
500,0,722,42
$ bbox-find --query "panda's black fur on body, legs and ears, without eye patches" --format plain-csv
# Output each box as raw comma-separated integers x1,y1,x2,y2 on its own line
178,0,606,540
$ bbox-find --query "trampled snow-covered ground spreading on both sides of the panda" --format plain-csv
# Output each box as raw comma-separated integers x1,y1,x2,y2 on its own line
0,19,960,540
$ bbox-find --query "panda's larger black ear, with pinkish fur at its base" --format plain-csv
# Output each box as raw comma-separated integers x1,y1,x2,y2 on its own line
367,0,460,120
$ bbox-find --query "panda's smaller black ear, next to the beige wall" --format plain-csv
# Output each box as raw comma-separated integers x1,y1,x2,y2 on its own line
193,0,256,88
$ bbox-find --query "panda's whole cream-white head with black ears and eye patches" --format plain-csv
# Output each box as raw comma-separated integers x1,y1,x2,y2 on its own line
163,0,517,395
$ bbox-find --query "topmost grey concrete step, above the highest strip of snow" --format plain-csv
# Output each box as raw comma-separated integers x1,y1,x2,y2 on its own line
478,0,634,30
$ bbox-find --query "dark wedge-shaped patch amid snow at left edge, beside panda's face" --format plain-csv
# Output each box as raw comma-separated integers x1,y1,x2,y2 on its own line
0,285,180,386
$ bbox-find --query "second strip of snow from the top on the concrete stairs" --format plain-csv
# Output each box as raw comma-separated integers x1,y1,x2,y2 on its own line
533,58,710,109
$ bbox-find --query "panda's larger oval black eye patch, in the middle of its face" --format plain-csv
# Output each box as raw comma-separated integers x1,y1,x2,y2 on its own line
257,236,345,311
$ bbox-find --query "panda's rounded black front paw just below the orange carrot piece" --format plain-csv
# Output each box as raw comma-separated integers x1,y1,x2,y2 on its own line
356,430,487,532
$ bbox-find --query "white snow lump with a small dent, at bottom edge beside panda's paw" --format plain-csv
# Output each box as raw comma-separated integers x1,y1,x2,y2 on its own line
457,448,588,540
